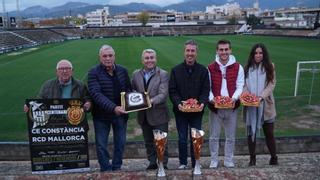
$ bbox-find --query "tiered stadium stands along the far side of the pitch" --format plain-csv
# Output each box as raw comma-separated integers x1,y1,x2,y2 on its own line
0,25,320,53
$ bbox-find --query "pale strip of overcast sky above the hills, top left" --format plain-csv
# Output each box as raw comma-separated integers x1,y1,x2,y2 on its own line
0,0,184,12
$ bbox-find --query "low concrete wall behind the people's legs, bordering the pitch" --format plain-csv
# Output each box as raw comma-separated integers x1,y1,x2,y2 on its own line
0,135,320,161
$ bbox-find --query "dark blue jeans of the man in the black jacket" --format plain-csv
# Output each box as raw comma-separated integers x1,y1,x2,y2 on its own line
174,112,202,167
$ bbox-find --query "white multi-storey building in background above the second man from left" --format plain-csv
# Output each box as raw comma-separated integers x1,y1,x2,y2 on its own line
86,7,110,27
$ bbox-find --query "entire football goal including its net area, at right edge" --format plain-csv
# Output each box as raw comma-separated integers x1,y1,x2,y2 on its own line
294,61,320,104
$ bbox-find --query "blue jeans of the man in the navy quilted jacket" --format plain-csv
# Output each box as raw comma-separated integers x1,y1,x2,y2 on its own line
93,116,127,171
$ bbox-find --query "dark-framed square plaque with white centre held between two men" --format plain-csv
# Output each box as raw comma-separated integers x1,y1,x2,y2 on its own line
121,92,151,112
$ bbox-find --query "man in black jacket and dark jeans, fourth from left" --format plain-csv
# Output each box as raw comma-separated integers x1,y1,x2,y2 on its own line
169,40,210,169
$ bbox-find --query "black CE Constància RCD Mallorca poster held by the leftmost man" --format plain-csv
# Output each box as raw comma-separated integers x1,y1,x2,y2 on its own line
26,99,90,174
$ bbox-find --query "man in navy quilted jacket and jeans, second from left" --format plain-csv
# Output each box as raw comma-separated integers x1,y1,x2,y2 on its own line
88,45,131,171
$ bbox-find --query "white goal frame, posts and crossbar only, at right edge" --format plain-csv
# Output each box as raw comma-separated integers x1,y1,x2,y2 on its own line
294,61,320,104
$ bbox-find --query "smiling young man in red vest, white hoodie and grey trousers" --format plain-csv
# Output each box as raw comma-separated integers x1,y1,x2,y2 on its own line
208,40,244,168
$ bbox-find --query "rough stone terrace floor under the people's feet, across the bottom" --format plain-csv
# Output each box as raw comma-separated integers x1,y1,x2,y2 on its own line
0,152,320,180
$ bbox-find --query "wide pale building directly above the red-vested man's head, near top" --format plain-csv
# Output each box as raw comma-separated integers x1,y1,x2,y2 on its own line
206,2,241,16
